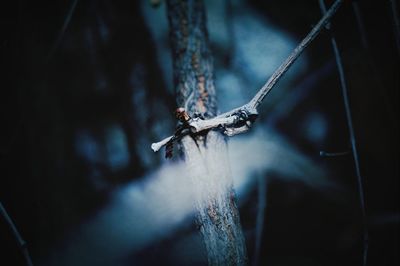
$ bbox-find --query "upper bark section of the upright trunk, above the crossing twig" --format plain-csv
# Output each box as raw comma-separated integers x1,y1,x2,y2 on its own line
167,0,217,117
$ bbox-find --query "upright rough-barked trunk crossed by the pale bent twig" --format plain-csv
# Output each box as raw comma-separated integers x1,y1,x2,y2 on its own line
167,0,247,265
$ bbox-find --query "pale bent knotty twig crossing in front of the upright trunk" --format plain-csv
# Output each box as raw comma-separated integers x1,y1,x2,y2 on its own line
151,0,343,152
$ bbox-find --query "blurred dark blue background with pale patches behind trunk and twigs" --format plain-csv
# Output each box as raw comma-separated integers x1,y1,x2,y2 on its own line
0,0,400,266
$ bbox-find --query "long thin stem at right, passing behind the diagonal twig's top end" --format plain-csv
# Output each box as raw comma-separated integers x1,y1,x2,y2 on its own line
319,0,369,266
